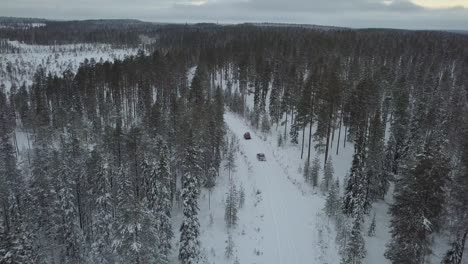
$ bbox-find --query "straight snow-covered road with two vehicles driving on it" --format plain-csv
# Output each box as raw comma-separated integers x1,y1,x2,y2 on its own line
225,113,337,264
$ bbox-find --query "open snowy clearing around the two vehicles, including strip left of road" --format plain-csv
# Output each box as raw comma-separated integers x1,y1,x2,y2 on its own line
171,113,340,264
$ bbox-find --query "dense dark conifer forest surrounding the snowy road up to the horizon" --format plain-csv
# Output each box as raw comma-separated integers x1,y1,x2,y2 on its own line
0,21,468,264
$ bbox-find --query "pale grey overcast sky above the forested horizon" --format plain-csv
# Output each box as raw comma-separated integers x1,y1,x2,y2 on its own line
0,0,468,30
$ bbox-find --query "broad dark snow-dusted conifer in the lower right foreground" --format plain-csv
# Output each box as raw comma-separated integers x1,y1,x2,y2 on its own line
385,137,450,264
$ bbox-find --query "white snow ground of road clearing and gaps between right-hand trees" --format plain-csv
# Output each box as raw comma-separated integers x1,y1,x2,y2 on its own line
184,69,458,264
